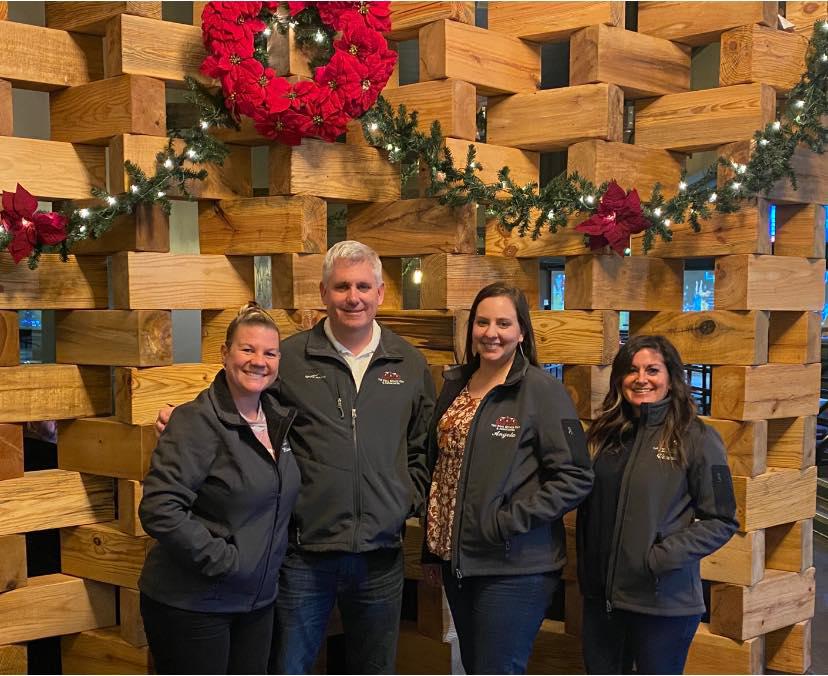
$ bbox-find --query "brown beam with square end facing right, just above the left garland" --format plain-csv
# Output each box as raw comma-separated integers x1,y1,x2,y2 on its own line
49,75,167,145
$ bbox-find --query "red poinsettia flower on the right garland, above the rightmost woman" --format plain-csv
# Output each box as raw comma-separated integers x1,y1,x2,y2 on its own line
575,181,650,256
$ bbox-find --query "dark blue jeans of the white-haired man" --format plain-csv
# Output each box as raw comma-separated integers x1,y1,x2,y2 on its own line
269,547,403,674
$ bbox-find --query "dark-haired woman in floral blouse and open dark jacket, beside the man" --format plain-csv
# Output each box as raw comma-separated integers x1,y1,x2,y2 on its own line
423,283,592,674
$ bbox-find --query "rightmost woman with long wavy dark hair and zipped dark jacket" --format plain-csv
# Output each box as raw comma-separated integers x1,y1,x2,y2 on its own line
577,336,738,674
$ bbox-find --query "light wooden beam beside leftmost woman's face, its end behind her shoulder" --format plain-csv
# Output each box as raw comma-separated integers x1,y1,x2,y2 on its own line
115,364,221,425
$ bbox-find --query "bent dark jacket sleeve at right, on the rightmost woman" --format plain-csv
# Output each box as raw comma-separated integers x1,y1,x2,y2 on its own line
647,425,739,575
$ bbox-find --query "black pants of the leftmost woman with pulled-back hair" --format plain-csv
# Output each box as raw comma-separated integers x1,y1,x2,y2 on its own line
141,594,273,674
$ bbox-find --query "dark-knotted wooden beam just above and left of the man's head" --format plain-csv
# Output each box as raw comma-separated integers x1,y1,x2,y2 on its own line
198,195,328,255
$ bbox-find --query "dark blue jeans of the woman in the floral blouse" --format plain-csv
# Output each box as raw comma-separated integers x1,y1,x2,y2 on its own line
443,564,560,674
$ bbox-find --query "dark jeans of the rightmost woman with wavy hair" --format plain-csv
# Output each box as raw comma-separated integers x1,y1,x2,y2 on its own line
582,599,701,674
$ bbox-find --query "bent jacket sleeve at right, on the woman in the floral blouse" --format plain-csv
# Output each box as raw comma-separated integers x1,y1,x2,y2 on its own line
497,380,594,539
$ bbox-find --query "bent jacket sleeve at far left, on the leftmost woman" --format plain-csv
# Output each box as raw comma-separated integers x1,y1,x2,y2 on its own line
139,407,238,577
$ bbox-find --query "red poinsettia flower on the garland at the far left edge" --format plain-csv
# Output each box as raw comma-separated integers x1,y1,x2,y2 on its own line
0,183,69,263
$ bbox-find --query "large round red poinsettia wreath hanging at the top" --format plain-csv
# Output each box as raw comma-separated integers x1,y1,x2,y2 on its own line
201,2,397,145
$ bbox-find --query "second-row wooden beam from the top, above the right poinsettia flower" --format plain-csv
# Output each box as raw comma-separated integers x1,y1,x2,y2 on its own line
569,24,690,99
